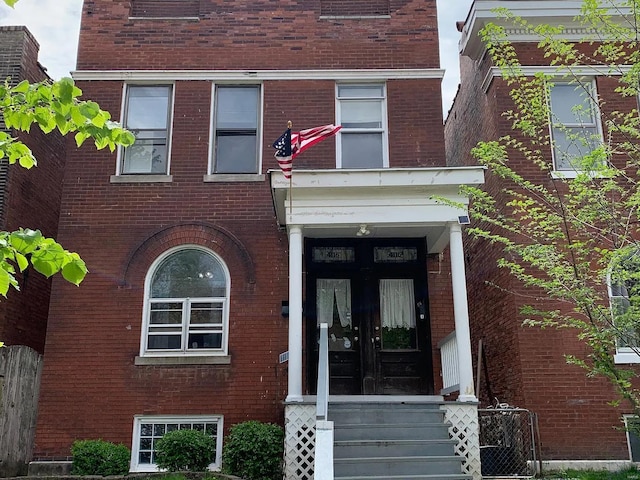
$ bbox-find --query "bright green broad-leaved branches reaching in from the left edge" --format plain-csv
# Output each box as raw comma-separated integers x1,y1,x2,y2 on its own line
0,0,134,346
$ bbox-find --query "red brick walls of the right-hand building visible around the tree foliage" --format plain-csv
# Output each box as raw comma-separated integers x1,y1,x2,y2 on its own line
445,14,637,460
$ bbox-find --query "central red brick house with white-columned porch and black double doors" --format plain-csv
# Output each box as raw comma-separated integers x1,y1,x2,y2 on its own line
35,0,483,479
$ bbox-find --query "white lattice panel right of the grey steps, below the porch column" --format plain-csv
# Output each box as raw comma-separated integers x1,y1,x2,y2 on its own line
442,403,482,480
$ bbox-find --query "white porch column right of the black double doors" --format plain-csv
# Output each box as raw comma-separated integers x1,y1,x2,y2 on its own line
449,223,478,402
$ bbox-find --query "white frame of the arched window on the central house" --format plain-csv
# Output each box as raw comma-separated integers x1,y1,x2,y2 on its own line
140,244,231,357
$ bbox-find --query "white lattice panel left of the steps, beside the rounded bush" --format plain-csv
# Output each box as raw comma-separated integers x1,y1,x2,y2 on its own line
284,403,316,480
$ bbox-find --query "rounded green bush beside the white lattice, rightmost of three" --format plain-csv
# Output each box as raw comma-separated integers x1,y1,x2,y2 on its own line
222,420,284,480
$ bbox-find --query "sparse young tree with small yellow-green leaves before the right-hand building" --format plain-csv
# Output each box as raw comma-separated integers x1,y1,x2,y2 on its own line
458,0,640,416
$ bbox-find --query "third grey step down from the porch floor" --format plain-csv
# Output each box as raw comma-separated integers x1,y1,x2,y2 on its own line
333,438,455,458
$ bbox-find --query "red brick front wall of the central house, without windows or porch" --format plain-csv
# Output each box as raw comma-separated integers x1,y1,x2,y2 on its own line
35,0,453,459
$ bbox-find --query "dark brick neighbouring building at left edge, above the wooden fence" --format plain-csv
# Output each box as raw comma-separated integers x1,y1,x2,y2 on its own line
0,27,65,353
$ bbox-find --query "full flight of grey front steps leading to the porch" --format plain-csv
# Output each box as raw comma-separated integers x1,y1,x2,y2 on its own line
329,402,471,480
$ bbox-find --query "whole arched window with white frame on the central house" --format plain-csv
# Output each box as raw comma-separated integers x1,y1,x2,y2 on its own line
141,246,230,356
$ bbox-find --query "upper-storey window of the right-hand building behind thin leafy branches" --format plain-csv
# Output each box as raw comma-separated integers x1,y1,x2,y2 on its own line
550,80,602,173
